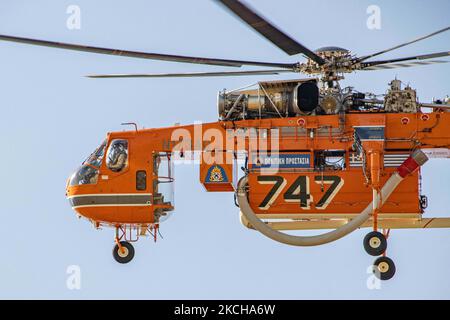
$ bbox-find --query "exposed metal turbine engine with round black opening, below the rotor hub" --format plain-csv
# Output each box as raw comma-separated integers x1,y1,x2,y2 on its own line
217,79,366,120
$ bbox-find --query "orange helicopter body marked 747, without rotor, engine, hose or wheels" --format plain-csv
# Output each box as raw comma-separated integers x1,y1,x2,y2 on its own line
67,111,450,227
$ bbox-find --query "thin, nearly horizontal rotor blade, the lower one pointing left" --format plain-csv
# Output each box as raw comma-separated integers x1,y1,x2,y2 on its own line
87,69,292,78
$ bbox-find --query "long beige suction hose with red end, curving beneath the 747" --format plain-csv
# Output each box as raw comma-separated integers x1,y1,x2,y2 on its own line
237,149,428,247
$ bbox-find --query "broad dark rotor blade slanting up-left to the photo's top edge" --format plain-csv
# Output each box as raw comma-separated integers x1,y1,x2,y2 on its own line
216,0,326,65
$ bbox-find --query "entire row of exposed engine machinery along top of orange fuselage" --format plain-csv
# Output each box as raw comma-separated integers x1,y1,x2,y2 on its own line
218,79,440,120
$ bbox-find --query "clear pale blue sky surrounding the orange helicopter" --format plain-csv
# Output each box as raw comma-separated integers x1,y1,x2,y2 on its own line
0,0,450,299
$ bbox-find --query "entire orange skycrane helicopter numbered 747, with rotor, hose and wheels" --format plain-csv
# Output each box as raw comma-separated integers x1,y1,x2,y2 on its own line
0,0,450,280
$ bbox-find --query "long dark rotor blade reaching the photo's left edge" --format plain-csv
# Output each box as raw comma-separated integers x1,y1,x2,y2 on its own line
0,35,295,69
